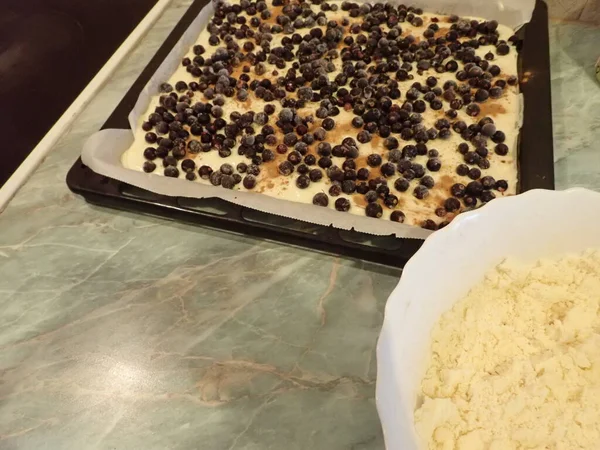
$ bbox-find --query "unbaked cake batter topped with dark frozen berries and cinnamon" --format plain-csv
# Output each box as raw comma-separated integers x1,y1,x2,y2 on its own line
122,0,520,229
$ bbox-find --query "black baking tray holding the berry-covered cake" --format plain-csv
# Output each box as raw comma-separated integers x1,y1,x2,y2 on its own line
67,0,554,267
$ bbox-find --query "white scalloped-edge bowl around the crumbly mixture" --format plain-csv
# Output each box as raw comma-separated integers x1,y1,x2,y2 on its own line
376,189,600,450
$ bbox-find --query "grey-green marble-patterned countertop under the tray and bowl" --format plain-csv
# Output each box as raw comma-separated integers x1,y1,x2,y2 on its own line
0,0,600,450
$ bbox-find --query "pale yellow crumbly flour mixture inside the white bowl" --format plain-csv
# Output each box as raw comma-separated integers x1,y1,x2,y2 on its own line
415,251,600,450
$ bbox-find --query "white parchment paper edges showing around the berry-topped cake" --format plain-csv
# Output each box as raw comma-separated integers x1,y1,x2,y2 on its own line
81,0,535,239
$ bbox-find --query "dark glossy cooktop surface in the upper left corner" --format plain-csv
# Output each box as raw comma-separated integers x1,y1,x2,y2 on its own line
0,0,157,187
